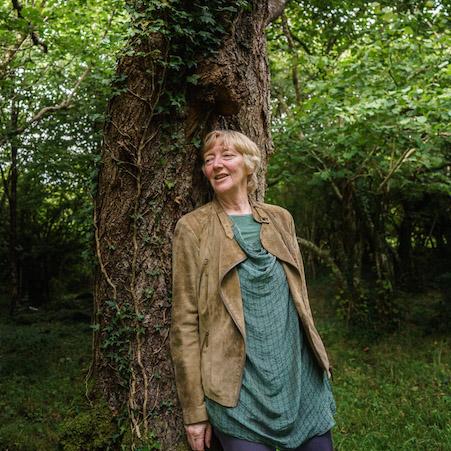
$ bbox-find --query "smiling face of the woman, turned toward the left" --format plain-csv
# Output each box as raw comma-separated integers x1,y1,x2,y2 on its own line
202,140,248,197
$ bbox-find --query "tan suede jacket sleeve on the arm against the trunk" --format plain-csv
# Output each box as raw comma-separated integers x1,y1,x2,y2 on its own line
170,218,208,424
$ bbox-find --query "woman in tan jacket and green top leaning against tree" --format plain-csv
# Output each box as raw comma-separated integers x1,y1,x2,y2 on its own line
170,130,335,451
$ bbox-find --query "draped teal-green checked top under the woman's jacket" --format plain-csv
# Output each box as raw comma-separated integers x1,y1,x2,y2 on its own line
205,215,335,449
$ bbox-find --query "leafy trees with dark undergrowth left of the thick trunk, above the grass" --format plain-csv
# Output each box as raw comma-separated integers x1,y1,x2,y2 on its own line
0,0,124,313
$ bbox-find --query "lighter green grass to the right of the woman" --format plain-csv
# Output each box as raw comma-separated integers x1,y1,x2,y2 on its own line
325,325,451,451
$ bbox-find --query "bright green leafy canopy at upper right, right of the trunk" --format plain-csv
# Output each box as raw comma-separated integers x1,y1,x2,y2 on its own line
273,3,451,194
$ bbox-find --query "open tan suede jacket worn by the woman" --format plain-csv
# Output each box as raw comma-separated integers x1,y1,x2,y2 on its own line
170,199,330,424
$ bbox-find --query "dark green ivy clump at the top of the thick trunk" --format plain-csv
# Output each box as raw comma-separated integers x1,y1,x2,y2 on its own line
118,0,248,114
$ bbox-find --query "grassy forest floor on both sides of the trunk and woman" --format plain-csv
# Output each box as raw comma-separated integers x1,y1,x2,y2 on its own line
0,289,451,451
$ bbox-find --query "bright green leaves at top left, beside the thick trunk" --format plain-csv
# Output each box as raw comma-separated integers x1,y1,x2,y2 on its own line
0,0,126,136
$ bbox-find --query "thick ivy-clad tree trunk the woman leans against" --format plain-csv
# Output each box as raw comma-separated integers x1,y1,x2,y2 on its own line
93,0,284,450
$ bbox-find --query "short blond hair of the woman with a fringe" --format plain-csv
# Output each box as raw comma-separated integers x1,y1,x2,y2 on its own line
202,130,261,193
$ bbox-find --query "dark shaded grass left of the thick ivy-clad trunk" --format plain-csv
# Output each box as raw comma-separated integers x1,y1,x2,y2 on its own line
0,298,91,451
